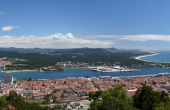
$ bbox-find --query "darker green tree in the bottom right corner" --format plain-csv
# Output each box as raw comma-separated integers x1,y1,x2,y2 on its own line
133,84,170,110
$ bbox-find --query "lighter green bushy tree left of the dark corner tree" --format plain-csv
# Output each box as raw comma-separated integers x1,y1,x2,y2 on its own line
90,85,135,110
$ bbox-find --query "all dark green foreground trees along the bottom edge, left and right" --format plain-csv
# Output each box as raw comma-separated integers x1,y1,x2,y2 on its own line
0,84,170,110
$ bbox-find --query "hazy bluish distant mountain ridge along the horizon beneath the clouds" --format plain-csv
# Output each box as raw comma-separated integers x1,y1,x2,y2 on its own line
0,47,143,54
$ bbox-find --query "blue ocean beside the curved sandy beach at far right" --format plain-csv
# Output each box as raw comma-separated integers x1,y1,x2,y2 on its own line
139,52,170,63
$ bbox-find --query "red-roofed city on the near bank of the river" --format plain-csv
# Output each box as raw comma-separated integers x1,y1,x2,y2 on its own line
0,74,170,109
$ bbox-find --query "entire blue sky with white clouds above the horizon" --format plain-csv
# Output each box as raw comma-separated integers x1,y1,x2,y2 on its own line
0,0,170,50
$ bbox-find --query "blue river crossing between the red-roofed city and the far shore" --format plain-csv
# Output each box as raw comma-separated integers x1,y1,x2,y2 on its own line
0,68,170,80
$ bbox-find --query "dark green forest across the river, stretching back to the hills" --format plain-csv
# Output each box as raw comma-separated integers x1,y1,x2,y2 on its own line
0,49,149,70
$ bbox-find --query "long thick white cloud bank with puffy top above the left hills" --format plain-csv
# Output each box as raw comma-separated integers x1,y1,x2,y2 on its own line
0,33,113,49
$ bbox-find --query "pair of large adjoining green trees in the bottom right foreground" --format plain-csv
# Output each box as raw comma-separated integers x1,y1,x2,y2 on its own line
90,84,170,110
